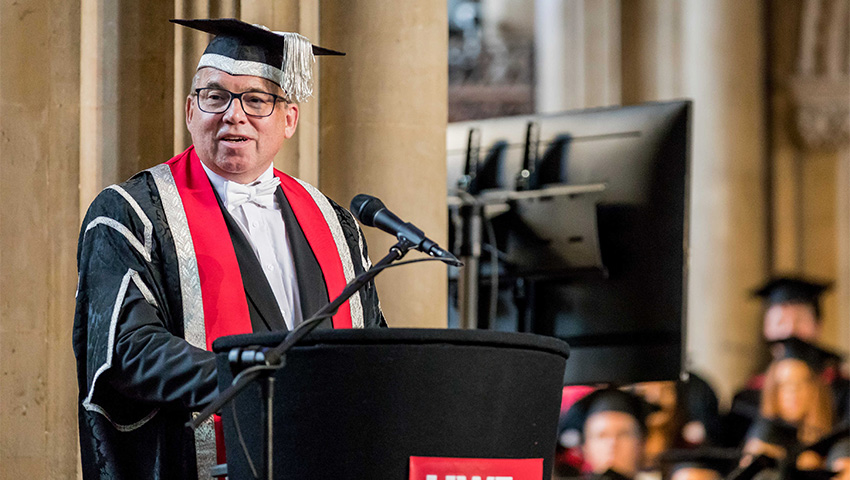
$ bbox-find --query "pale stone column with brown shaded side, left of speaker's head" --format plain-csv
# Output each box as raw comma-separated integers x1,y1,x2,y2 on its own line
80,0,175,206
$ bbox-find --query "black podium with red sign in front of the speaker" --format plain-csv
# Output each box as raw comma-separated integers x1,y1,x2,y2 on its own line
213,329,569,480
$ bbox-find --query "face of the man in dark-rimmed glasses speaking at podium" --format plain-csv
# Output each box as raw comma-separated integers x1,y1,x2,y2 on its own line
186,68,298,183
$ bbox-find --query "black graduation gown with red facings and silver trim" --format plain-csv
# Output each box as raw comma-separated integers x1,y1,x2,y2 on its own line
73,147,386,480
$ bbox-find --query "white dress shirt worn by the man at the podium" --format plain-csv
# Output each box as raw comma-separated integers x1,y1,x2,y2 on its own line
201,162,303,330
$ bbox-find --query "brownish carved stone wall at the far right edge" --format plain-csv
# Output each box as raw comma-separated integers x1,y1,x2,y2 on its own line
768,0,850,350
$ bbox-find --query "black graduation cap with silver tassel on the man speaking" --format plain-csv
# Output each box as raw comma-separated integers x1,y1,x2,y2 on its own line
171,18,345,101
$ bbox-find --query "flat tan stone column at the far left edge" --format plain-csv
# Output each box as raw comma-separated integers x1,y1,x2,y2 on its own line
0,0,81,479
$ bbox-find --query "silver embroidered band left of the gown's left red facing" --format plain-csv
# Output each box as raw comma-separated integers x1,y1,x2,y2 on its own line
148,164,216,480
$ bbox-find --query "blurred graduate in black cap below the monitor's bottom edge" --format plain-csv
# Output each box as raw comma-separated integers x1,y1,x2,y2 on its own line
560,388,658,478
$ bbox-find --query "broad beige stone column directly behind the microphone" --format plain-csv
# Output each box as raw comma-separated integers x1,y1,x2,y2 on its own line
319,0,448,327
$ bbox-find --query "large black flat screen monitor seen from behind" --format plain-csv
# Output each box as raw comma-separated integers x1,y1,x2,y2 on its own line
447,101,691,384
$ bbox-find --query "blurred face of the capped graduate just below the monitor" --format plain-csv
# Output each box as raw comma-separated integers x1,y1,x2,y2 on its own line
582,411,643,477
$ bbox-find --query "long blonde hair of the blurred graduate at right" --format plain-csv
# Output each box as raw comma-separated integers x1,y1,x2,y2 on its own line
761,359,833,443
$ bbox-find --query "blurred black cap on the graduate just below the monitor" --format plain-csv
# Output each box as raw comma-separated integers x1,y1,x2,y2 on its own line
559,387,660,433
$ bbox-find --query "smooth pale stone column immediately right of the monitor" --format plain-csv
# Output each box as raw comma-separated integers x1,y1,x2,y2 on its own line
682,0,769,398
